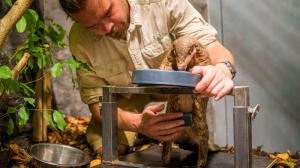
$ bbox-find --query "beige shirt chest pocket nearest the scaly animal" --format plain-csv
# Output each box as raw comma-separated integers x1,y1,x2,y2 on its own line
141,35,172,68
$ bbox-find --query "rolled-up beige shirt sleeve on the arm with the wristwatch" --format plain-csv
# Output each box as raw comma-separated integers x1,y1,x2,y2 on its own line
166,0,217,45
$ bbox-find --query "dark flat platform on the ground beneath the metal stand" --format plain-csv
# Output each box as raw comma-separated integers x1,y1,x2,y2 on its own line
99,146,275,168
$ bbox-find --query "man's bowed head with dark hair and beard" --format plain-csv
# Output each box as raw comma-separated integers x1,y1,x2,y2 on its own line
59,0,129,39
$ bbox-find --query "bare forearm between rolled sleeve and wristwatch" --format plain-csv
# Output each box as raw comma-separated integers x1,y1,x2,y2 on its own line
207,41,234,65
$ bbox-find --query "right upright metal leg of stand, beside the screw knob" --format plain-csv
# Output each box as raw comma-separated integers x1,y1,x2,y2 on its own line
233,86,252,168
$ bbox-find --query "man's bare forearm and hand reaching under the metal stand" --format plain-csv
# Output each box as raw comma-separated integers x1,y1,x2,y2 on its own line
88,103,185,141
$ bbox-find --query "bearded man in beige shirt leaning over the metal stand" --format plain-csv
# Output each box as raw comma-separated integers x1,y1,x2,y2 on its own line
60,0,234,154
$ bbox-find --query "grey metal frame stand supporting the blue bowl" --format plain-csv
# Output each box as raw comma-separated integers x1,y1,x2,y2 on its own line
100,86,253,168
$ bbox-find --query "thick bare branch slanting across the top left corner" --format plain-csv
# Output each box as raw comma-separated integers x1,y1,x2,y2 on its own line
0,0,33,48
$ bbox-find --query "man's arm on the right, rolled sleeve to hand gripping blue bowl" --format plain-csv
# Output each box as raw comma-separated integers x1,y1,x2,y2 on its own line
166,0,234,100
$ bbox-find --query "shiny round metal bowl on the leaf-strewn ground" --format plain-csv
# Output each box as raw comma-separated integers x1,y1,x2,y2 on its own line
30,143,90,168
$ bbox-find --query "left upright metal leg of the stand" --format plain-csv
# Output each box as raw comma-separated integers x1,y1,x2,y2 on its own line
101,87,118,165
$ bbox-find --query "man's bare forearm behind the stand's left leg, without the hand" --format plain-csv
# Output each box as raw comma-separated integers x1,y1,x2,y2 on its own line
88,103,141,132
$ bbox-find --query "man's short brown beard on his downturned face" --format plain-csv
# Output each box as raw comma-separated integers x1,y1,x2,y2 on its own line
107,22,129,40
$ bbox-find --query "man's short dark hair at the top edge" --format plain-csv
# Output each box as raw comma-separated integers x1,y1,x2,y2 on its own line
59,0,87,15
